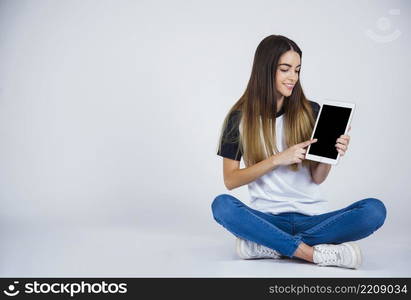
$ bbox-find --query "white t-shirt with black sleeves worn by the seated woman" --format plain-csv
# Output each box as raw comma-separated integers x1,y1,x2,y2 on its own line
217,101,329,216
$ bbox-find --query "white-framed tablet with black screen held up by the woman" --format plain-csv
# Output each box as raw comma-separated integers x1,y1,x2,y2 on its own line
305,100,355,165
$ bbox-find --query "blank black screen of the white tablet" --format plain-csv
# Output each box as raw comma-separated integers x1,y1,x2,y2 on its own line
308,104,351,159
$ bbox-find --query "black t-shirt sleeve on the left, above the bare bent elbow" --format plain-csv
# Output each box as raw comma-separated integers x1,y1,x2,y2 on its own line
217,111,242,161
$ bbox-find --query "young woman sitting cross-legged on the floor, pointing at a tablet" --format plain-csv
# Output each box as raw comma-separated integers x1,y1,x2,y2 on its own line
212,35,386,269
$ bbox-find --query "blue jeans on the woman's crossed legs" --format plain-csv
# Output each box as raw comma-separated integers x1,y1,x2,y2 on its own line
211,194,386,257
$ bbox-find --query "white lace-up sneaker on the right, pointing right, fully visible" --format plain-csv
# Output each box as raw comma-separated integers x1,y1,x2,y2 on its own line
313,242,362,269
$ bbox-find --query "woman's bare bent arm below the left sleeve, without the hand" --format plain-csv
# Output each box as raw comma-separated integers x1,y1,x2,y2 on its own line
223,155,280,190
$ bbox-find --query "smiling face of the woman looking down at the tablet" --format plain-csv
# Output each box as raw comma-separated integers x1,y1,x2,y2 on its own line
275,50,301,97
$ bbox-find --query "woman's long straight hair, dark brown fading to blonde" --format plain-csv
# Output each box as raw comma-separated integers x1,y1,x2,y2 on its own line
218,35,315,171
